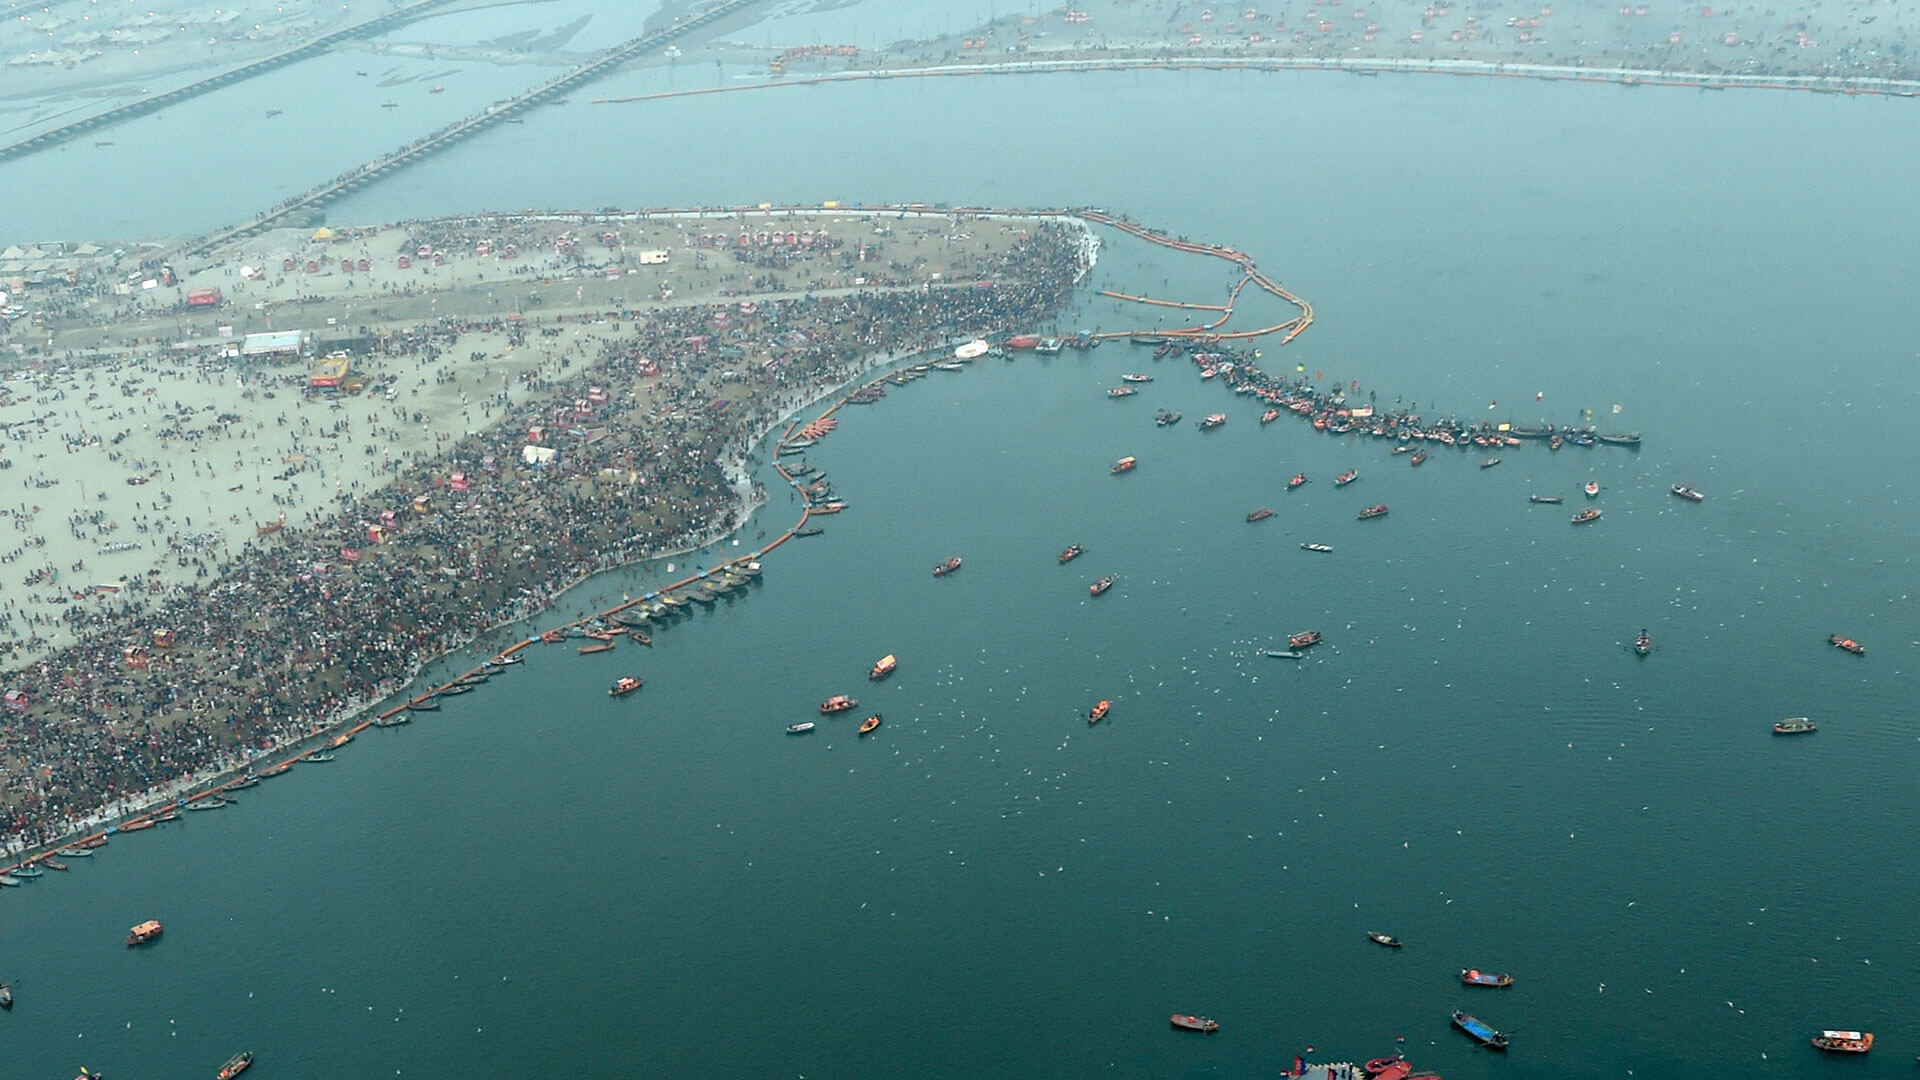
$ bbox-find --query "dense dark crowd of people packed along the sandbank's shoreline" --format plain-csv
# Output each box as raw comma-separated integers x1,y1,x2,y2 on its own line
0,225,1081,851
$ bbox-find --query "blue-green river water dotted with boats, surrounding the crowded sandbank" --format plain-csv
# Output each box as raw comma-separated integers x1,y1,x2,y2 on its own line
0,35,1920,1080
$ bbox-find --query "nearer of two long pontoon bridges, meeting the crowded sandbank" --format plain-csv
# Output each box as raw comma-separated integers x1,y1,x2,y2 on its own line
180,0,758,256
